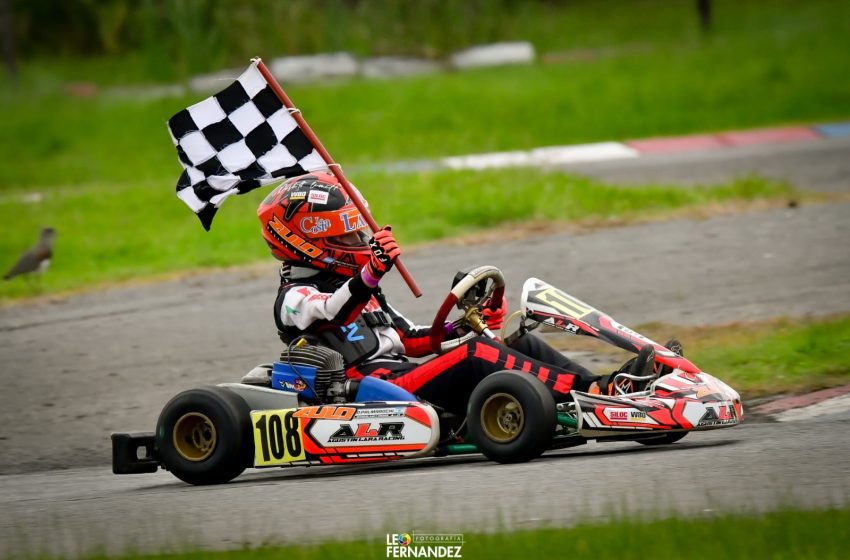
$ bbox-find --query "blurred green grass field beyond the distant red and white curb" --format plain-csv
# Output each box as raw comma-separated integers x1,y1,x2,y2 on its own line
0,0,850,190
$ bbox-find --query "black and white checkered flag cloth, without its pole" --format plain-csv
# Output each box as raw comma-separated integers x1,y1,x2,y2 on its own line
168,62,327,231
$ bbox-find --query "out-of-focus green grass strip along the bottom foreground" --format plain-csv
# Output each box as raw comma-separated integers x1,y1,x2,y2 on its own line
21,508,850,560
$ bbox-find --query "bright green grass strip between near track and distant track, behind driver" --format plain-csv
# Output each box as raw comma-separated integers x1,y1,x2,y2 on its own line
0,170,796,301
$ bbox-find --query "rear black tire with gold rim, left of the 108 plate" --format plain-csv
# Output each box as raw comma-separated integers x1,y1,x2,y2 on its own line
156,386,254,485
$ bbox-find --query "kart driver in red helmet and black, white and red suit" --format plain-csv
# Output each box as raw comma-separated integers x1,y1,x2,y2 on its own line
257,172,655,414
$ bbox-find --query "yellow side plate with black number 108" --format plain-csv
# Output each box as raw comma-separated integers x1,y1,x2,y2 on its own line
251,408,305,467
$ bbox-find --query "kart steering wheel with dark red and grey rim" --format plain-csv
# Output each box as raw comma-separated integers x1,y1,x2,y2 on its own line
424,266,505,354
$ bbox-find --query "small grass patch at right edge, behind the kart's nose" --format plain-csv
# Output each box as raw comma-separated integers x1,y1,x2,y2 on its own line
688,316,850,398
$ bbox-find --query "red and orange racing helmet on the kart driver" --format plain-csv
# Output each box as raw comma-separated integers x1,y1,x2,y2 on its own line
257,172,372,277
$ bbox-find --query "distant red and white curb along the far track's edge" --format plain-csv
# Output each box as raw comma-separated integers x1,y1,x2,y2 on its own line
430,122,850,170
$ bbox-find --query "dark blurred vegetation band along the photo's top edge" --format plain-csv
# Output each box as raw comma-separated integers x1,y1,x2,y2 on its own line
6,0,848,83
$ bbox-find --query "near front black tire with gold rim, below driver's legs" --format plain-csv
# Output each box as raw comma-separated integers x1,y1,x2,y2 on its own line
467,371,557,463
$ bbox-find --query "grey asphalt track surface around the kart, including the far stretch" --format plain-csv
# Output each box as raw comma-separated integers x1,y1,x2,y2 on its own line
0,136,850,556
